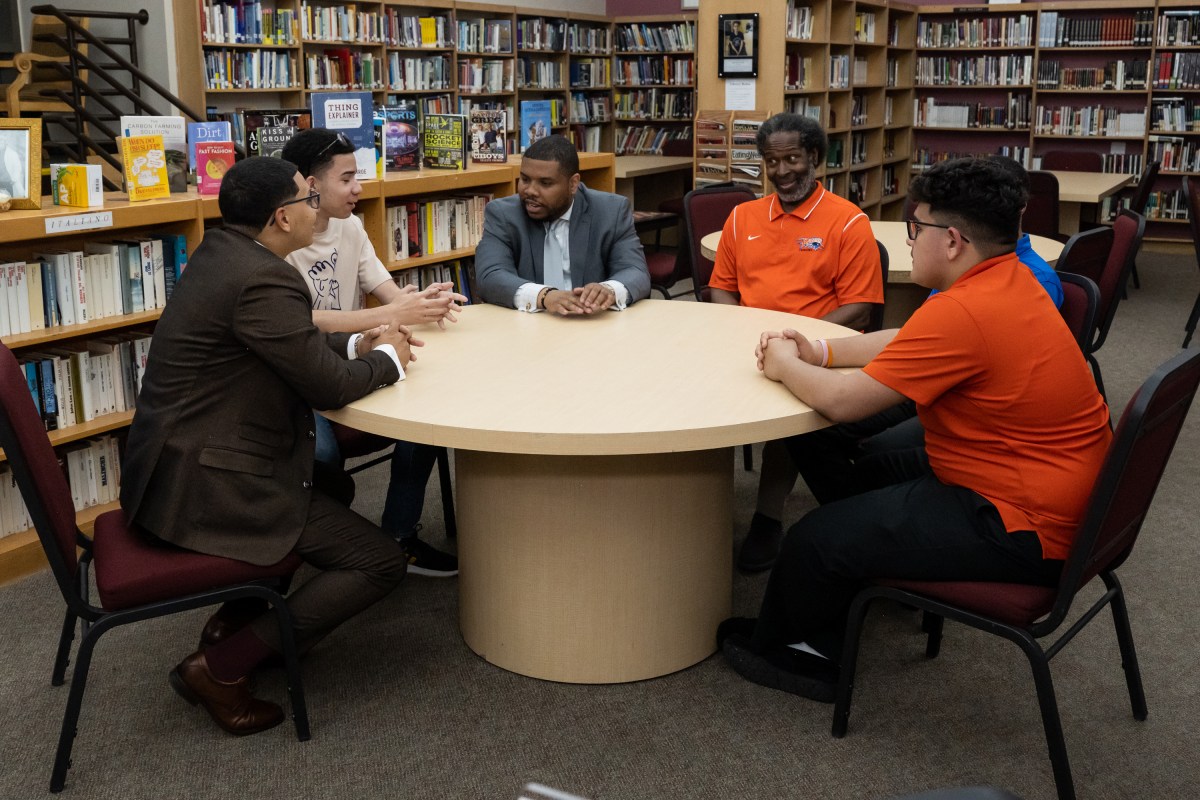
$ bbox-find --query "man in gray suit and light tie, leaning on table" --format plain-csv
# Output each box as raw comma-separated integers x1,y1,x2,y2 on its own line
475,136,650,315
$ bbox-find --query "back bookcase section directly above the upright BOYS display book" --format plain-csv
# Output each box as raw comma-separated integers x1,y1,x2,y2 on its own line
455,2,517,152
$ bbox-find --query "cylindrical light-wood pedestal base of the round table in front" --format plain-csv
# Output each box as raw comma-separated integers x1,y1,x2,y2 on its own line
455,449,733,684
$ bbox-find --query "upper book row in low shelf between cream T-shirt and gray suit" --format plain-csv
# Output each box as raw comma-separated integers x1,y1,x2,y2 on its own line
388,194,492,263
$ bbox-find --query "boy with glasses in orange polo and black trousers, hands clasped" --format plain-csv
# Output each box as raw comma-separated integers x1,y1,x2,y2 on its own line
718,158,1111,702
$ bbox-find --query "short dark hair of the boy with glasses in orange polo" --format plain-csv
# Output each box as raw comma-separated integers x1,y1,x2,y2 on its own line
908,158,1030,255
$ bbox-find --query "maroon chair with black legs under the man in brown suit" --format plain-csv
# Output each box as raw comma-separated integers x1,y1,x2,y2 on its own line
0,344,310,792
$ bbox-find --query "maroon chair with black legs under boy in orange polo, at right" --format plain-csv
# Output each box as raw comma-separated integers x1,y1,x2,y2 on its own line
833,350,1200,800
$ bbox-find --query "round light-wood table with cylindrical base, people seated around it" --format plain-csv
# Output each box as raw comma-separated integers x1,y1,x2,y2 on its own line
329,300,847,684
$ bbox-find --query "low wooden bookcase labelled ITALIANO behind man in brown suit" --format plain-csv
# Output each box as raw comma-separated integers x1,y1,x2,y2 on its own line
0,192,202,583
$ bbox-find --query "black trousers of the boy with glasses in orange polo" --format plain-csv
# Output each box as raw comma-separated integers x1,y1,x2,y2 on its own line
754,407,1062,656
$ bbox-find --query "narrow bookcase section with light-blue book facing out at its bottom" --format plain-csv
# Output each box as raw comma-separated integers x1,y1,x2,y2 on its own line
514,13,570,151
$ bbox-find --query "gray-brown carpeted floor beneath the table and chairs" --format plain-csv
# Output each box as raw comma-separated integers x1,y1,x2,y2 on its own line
0,252,1200,800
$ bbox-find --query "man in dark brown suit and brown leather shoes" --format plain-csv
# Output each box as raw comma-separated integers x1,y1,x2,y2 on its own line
121,158,420,734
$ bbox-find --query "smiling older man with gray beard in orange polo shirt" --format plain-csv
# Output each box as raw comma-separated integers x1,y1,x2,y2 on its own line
708,114,883,572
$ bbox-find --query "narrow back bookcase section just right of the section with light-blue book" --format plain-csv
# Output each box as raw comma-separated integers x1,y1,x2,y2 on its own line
566,13,613,152
